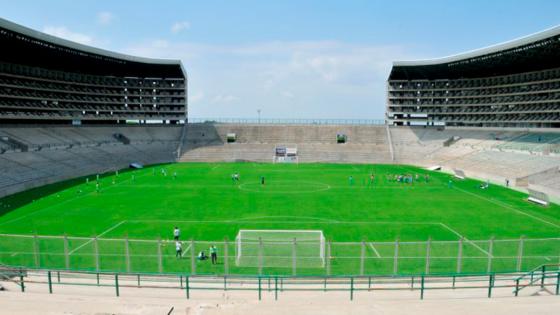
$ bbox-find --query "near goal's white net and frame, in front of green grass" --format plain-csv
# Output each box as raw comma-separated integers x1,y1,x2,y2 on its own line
235,230,325,268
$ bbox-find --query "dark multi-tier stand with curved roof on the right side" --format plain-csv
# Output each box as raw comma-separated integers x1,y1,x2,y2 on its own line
386,27,560,128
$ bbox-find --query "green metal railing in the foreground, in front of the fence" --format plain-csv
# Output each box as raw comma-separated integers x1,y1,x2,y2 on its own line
0,265,560,300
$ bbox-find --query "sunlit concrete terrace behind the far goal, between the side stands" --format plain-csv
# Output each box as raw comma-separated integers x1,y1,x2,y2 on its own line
180,123,391,163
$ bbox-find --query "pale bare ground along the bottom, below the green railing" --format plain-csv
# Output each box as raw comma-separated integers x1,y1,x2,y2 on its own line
0,282,560,315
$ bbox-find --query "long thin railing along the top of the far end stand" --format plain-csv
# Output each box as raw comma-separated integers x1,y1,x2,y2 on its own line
189,117,385,125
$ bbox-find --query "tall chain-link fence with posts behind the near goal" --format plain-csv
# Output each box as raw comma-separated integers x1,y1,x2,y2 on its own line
0,234,560,275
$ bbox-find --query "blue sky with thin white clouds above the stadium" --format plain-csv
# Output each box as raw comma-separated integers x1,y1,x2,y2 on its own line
0,0,560,119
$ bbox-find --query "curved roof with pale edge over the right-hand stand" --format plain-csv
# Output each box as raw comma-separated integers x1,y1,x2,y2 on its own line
389,26,560,80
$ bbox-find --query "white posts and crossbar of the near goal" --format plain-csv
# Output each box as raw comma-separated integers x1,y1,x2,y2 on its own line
235,229,326,267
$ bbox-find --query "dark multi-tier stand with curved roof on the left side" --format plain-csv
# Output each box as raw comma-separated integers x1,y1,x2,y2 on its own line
0,19,187,124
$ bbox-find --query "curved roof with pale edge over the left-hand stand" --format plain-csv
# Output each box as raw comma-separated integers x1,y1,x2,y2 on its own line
0,18,186,78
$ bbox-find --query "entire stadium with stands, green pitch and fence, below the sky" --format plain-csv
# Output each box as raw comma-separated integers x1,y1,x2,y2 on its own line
0,10,560,315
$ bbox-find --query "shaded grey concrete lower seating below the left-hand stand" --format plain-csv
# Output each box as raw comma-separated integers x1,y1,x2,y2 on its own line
0,125,182,196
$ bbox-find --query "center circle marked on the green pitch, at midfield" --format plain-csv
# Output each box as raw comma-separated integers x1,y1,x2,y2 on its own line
237,180,331,194
